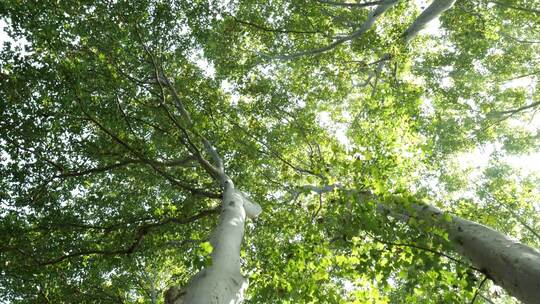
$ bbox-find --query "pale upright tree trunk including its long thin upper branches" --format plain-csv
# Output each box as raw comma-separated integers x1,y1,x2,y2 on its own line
154,74,262,304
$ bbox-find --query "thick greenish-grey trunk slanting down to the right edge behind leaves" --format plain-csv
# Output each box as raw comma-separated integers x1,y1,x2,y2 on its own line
383,201,540,304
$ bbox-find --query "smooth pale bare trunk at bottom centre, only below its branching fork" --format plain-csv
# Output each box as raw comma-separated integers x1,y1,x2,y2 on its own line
165,180,262,304
